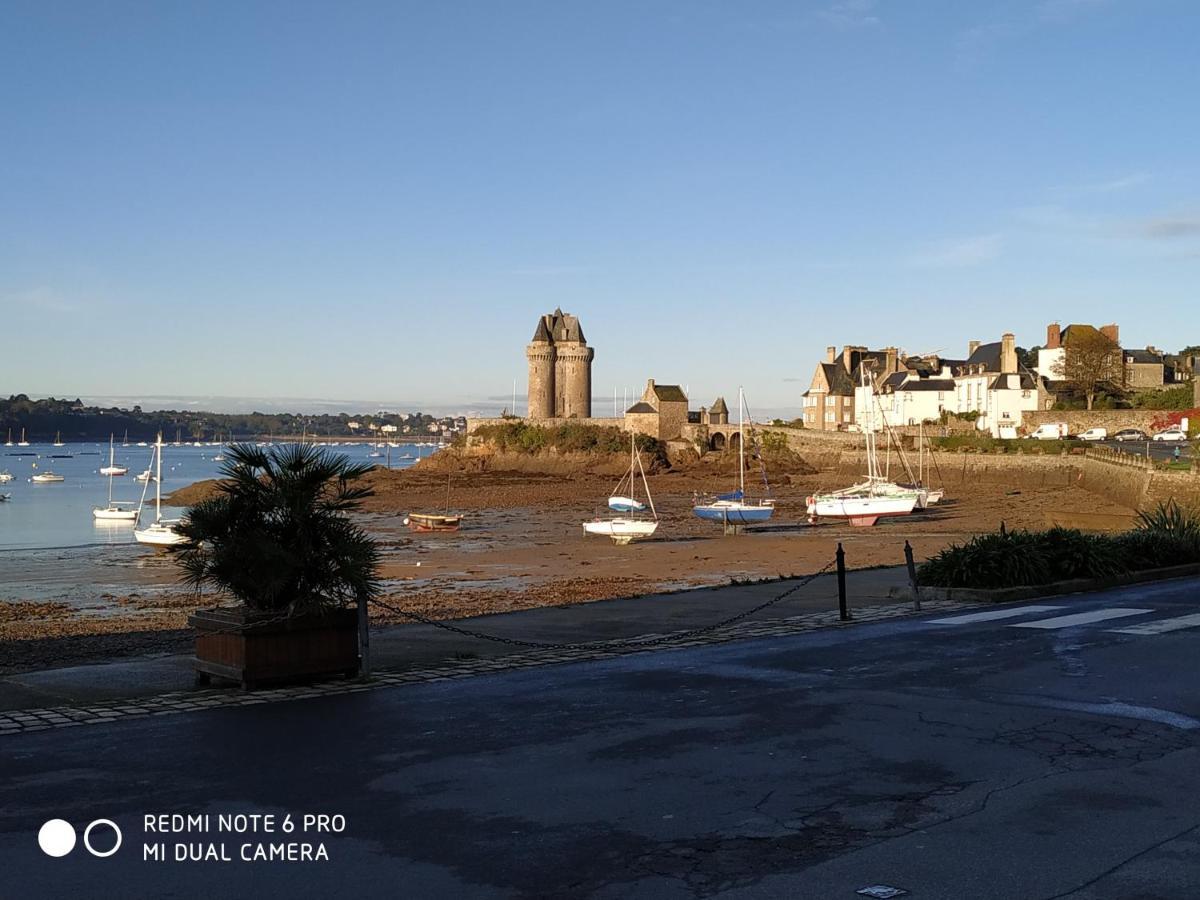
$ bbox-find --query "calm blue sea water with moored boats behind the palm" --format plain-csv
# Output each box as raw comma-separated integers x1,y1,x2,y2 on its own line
0,444,436,552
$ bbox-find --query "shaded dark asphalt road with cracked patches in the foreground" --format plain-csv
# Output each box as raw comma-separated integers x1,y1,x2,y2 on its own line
0,580,1200,900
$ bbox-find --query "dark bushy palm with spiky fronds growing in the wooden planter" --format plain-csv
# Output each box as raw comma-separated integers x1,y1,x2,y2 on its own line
178,444,379,616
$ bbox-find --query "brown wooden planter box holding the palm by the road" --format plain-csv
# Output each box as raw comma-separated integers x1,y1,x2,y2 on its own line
187,607,359,690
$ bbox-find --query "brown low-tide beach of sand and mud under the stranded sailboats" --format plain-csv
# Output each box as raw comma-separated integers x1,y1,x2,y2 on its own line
0,448,1132,668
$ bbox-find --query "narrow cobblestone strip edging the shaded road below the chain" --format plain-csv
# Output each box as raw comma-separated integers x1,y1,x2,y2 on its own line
0,600,964,738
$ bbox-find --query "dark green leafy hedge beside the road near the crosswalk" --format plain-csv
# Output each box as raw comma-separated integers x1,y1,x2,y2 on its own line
918,500,1200,589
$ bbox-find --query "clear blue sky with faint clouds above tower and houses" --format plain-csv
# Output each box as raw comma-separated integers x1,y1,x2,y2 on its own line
0,0,1200,410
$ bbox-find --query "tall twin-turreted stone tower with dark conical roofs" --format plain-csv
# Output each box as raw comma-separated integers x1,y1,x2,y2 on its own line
526,310,595,419
